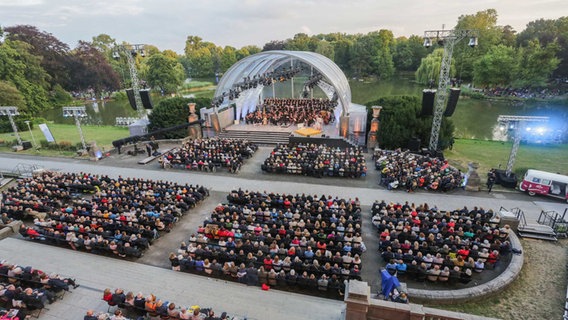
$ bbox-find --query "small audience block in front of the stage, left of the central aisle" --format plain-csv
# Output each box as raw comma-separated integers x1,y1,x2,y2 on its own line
160,138,258,173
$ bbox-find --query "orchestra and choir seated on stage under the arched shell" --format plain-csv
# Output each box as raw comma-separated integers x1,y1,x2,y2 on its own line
245,98,337,129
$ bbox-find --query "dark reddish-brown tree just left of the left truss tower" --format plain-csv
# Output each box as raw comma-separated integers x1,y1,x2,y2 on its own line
69,41,120,95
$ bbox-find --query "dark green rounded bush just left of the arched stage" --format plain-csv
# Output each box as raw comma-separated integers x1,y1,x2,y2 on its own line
148,97,211,139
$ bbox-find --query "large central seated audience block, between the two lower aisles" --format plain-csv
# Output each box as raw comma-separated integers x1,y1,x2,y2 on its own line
170,189,365,295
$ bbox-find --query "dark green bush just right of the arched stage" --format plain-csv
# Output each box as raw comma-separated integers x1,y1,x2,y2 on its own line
367,96,454,150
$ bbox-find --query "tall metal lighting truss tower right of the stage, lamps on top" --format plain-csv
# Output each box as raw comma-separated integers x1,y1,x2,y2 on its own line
424,29,479,151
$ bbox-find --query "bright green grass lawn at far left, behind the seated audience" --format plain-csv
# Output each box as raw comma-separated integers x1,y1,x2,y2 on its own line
0,123,129,156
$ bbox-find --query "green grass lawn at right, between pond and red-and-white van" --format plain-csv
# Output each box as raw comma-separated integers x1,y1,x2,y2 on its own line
444,139,568,178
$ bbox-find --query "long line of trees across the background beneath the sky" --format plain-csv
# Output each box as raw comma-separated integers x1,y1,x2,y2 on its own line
0,9,568,113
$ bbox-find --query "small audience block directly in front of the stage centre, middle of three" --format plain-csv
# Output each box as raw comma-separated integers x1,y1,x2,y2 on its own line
261,143,367,178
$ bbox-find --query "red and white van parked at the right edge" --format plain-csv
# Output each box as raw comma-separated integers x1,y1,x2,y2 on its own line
519,169,568,201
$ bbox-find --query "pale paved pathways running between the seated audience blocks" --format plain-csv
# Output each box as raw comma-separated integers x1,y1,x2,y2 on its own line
0,148,566,319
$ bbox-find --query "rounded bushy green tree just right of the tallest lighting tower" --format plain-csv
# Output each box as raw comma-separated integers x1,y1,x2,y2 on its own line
473,44,518,86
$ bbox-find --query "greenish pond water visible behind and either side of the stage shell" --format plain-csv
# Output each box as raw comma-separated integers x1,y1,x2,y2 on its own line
41,77,568,140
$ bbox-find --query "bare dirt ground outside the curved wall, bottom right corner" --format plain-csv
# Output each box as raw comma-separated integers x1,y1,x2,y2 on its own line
429,239,568,320
